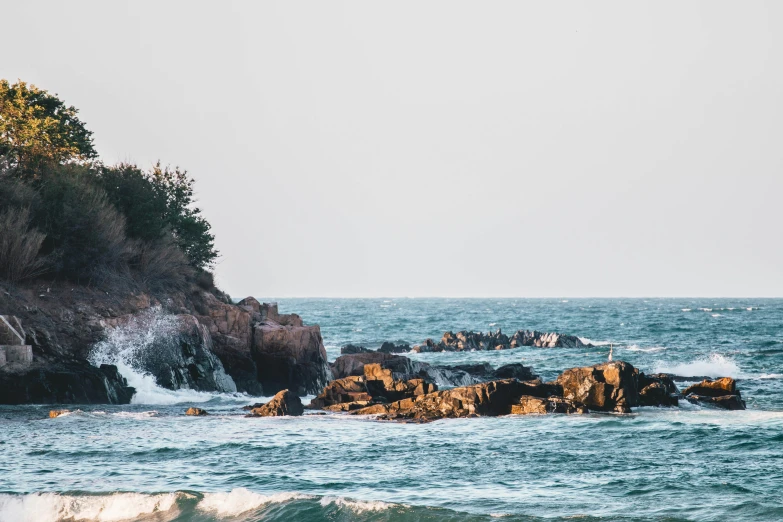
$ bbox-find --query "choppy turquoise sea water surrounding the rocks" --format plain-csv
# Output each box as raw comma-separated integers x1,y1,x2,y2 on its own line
0,299,783,521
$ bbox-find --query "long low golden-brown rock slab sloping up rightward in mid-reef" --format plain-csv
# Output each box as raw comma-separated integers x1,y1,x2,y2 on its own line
352,379,549,421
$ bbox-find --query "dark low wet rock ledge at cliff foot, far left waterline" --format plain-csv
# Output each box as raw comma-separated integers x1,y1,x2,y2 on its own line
0,360,136,404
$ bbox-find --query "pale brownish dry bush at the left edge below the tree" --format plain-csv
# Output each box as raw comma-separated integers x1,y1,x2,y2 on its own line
0,208,46,283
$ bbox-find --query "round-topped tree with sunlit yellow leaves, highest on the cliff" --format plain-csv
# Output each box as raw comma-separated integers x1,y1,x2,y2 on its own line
0,80,97,177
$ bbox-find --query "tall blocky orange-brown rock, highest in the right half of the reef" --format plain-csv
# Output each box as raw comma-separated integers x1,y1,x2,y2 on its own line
556,361,639,413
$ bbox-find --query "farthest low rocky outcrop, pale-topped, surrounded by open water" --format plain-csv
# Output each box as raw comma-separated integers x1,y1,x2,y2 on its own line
413,329,589,352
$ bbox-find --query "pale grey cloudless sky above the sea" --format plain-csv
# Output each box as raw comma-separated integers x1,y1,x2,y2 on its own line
0,0,783,297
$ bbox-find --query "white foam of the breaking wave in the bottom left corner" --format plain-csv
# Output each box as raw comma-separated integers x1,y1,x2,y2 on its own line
0,493,187,522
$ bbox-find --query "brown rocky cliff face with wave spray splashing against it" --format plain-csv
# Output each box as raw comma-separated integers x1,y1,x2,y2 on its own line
0,285,331,404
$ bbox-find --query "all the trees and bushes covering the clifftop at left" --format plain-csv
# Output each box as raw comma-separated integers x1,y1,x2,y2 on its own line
0,80,218,289
